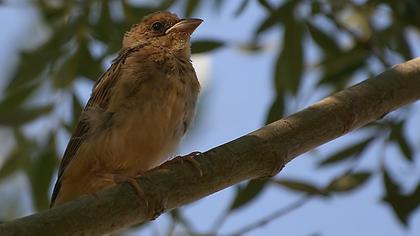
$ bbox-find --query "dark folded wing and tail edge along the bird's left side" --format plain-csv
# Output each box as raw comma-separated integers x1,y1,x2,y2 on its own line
50,46,141,206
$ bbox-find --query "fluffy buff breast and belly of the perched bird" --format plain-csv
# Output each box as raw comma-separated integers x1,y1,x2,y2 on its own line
88,68,198,175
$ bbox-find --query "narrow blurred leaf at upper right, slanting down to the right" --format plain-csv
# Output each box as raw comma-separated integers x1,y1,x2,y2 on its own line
306,21,341,54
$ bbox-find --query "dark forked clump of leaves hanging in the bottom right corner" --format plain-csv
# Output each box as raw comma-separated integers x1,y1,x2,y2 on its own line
382,170,420,226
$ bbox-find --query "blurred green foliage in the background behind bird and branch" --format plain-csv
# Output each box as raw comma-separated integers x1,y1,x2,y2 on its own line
0,0,420,233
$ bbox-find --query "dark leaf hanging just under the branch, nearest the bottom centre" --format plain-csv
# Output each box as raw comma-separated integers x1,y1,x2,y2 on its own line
229,179,267,211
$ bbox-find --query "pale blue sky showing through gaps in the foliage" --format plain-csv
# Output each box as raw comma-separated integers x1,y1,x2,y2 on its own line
0,0,420,236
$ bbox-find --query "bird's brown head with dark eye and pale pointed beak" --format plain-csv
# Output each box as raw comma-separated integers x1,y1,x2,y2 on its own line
123,12,203,56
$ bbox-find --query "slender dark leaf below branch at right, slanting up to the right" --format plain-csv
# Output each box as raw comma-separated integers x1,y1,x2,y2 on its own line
318,138,374,167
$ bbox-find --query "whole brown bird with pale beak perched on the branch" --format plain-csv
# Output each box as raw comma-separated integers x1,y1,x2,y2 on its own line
51,12,202,207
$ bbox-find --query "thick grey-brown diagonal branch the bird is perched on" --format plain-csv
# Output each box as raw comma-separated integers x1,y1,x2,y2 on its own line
0,58,420,235
